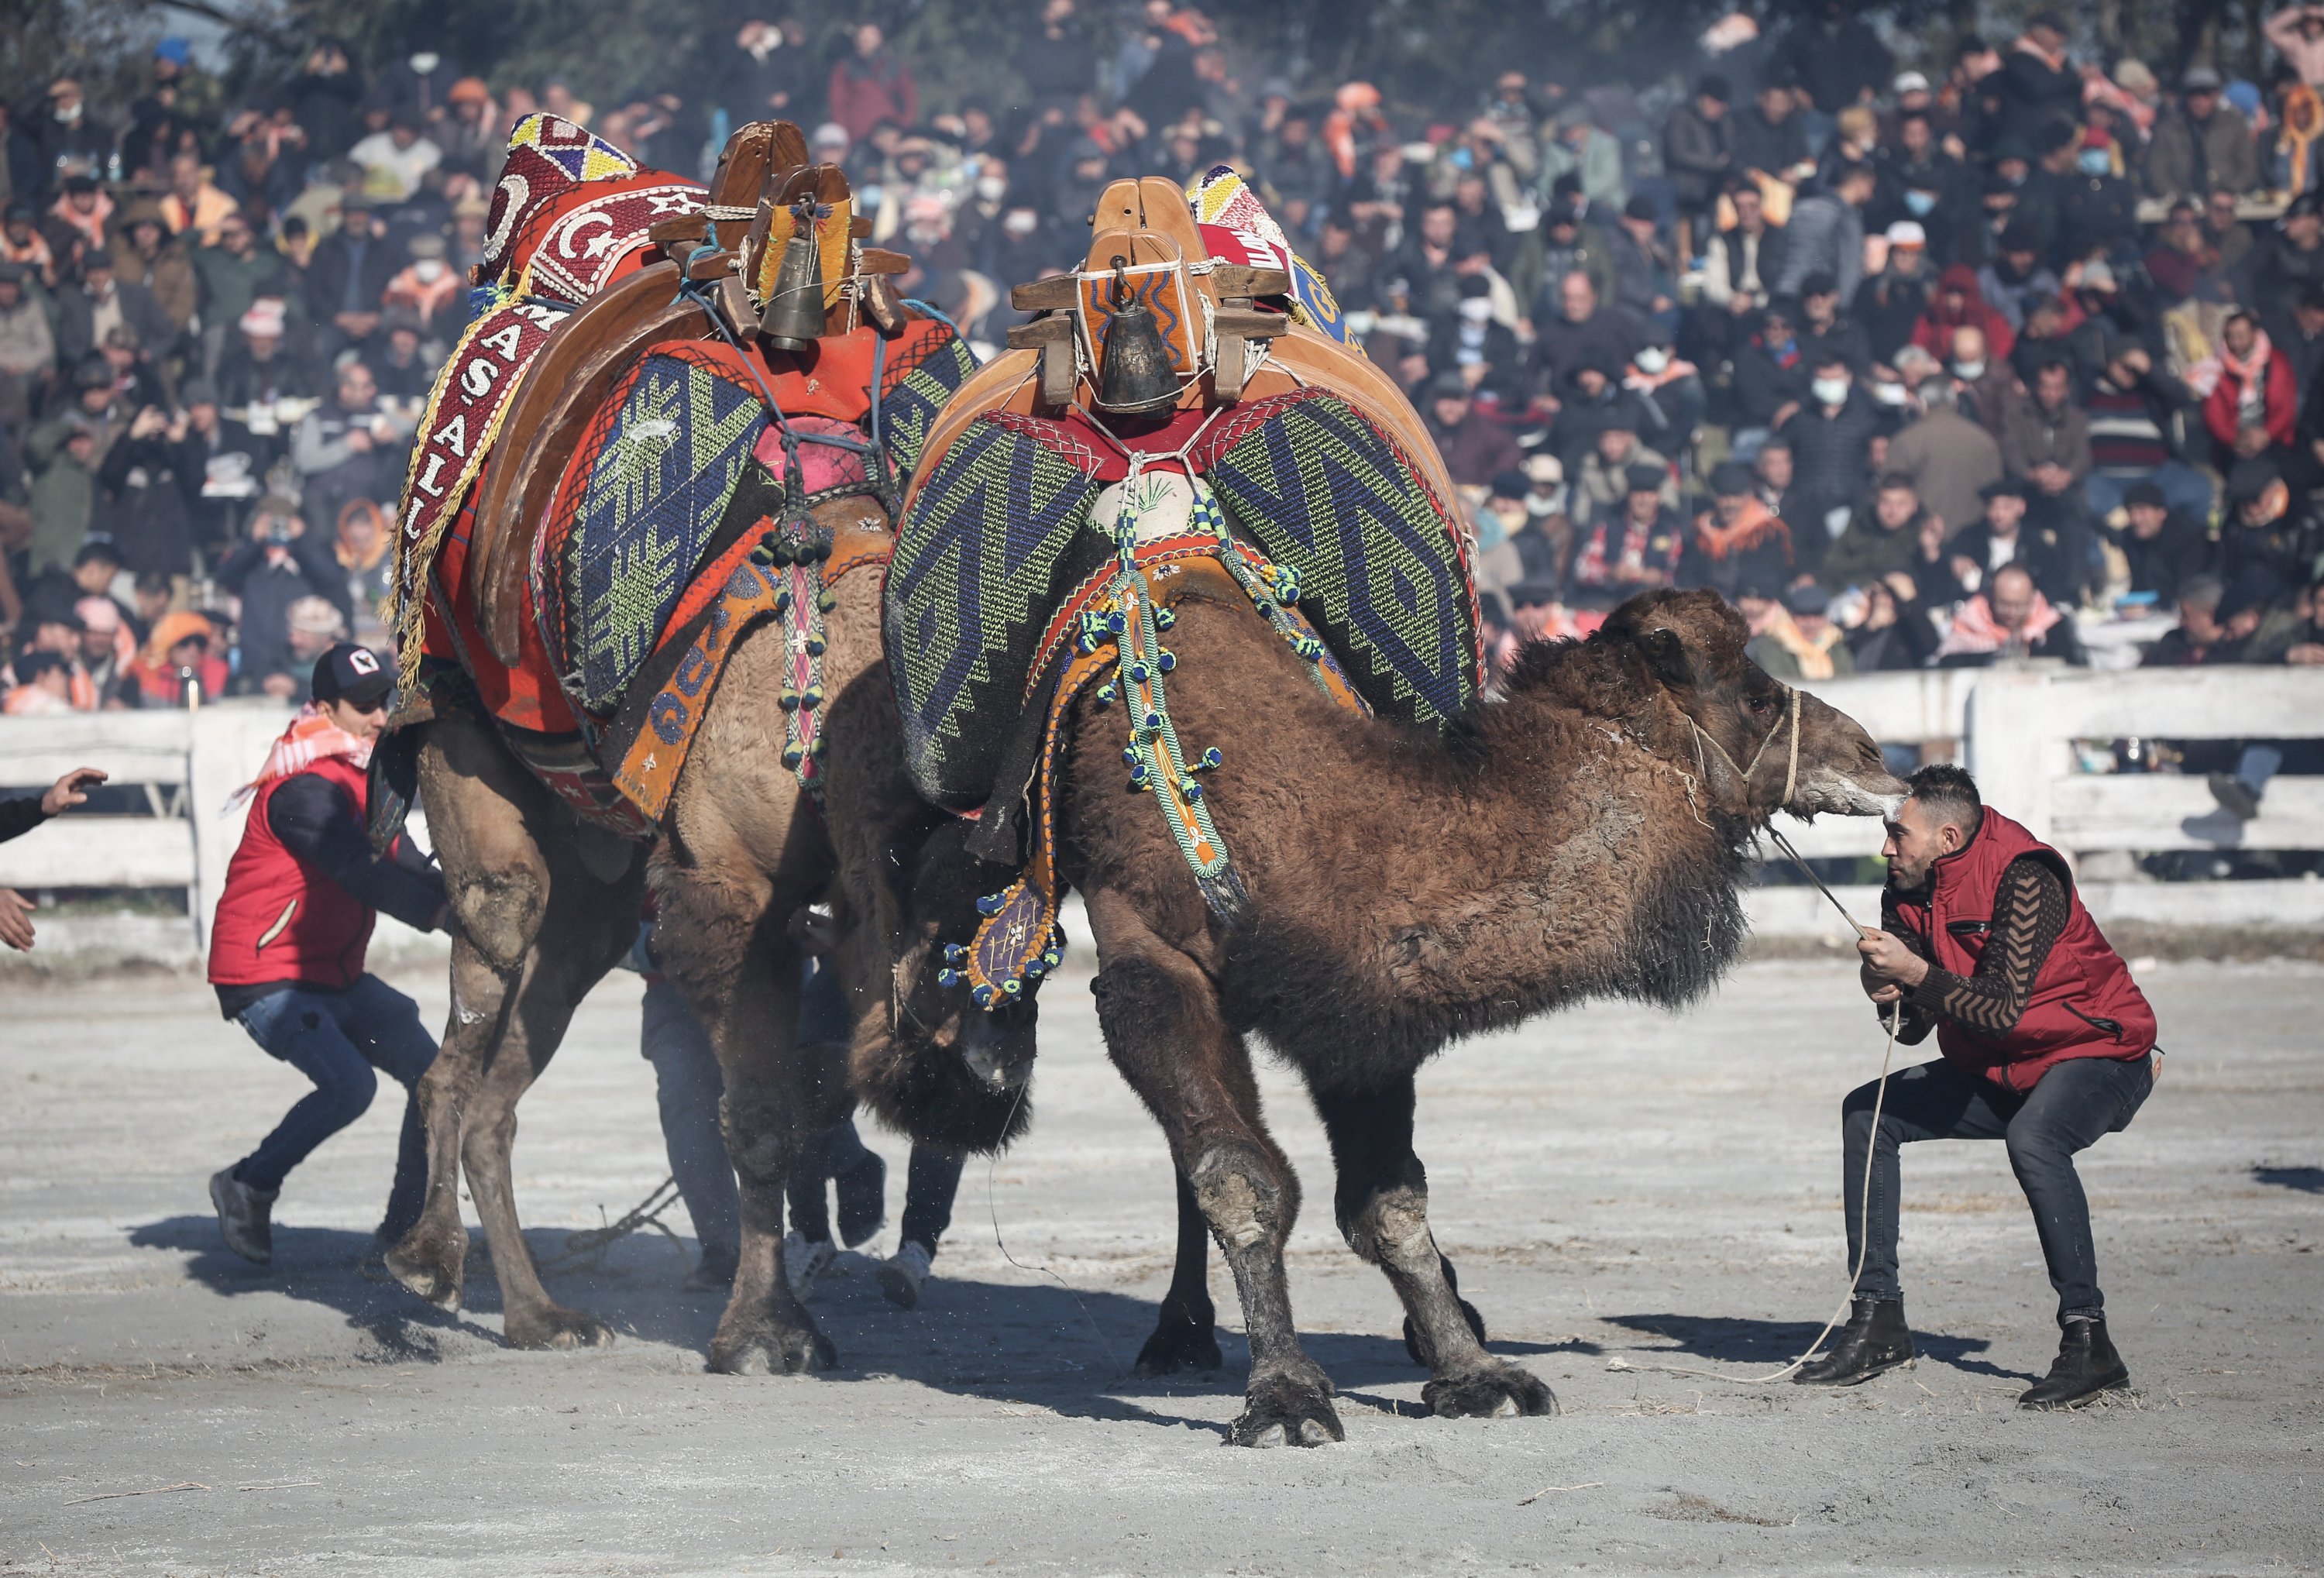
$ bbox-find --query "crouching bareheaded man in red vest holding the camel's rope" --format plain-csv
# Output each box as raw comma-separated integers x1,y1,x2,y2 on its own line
1796,767,2159,1408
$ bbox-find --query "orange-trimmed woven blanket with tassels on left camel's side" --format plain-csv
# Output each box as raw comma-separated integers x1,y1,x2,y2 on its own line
409,318,976,837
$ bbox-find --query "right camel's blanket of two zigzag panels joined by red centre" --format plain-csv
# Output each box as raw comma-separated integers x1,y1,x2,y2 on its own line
883,388,1480,811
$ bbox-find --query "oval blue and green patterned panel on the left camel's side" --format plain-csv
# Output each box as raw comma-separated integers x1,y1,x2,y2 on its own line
541,351,767,711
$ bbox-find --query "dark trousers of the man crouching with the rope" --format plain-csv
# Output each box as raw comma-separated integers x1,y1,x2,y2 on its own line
1841,1057,2154,1322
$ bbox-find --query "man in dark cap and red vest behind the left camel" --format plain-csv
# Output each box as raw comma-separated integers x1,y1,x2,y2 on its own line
209,641,444,1264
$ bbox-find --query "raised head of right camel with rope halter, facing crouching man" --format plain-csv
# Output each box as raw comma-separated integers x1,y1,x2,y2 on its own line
1601,590,1906,823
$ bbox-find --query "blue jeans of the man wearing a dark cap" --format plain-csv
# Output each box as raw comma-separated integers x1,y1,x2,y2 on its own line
235,976,437,1241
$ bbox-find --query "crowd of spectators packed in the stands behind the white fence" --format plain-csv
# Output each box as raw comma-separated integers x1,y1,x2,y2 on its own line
0,0,2324,730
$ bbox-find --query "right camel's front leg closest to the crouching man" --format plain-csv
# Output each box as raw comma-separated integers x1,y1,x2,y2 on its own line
1313,1074,1557,1418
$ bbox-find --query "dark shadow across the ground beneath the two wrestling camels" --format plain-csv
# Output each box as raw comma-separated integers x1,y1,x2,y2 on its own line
130,1215,1597,1432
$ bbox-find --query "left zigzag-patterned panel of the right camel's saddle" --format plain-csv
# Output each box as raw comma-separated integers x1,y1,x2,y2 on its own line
883,411,1113,811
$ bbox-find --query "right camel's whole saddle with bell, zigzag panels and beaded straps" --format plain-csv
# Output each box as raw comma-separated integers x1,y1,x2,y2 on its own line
883,170,1483,1009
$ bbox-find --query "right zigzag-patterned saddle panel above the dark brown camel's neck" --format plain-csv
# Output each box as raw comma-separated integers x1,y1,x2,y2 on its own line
1192,390,1483,727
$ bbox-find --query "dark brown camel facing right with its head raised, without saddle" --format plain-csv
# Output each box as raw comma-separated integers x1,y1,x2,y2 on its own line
834,593,1903,1446
